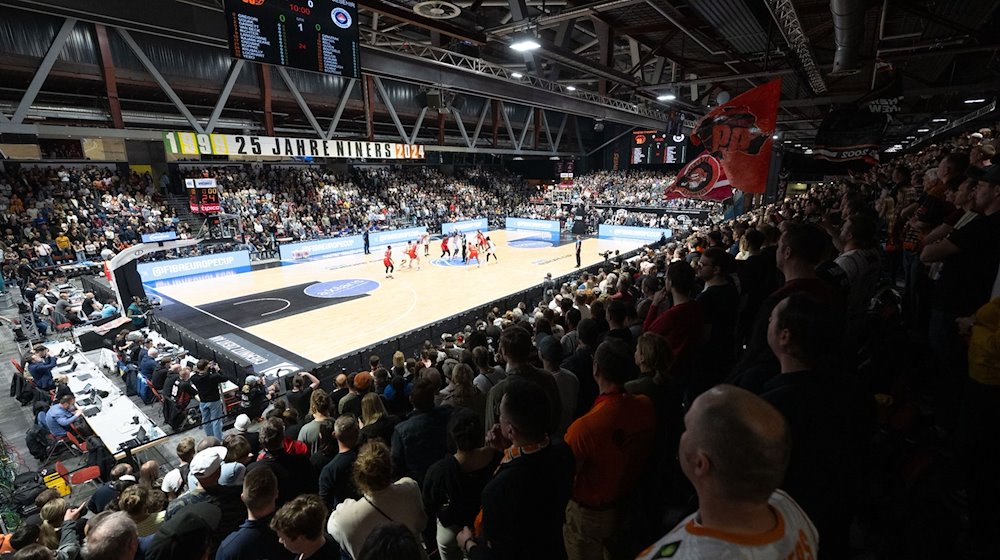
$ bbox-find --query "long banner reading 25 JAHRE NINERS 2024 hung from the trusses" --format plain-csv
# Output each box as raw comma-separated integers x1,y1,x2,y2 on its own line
163,132,424,159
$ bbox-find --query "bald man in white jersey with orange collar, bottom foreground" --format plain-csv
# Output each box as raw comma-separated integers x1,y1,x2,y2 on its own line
639,385,819,560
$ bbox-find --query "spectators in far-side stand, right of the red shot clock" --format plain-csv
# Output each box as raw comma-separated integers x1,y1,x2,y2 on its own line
189,166,526,254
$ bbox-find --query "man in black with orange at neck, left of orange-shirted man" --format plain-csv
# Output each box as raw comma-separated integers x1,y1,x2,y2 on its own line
458,378,576,560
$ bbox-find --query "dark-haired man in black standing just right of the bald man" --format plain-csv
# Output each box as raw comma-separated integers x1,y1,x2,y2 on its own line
760,293,875,558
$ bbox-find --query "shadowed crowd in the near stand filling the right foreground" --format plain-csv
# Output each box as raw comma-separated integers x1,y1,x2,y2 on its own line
12,121,1000,560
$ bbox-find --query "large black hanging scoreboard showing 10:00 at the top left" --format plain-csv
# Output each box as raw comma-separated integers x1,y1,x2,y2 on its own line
226,0,361,78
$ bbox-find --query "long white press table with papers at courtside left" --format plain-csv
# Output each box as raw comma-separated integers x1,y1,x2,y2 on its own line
45,342,166,456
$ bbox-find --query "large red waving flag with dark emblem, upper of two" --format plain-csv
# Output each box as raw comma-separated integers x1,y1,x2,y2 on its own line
691,80,781,193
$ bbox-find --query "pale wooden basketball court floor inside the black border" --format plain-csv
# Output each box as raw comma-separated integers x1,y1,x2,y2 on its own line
155,230,642,363
